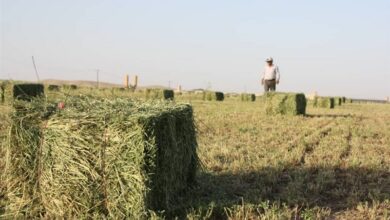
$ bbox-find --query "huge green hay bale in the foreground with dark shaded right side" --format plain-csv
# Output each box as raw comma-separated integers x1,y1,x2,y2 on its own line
7,98,198,219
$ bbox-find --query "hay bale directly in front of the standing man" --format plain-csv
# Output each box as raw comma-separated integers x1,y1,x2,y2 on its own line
264,92,306,115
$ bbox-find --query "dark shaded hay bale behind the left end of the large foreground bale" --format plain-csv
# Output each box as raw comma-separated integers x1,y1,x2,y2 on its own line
13,83,44,101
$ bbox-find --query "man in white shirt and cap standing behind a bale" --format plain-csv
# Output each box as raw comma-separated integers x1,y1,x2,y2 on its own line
261,57,280,92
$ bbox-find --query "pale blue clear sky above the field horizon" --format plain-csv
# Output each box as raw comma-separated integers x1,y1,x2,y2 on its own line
0,0,390,99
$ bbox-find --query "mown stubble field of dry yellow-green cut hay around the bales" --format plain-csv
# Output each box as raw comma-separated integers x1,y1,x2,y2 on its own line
0,93,390,219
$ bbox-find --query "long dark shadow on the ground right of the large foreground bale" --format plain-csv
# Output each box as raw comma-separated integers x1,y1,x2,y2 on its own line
172,165,390,218
